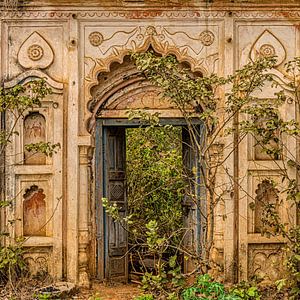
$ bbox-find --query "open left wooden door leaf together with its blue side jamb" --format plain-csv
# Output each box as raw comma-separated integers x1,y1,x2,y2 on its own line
97,126,128,282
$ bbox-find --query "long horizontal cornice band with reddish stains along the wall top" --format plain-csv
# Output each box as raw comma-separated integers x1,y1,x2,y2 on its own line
0,5,300,21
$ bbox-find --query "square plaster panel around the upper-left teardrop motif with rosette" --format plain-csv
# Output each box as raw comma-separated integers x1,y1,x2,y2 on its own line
8,22,64,82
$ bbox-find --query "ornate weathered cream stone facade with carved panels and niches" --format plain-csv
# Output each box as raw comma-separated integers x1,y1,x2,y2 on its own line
0,0,300,285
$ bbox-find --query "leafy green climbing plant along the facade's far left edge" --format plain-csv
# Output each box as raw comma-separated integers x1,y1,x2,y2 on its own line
0,80,60,283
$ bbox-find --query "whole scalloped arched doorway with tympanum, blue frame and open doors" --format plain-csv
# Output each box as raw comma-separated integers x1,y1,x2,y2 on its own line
90,58,203,282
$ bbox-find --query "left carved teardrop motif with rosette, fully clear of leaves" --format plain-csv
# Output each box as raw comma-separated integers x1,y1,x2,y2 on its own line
18,31,54,69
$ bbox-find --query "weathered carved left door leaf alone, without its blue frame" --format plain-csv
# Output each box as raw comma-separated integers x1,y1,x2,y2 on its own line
104,127,128,282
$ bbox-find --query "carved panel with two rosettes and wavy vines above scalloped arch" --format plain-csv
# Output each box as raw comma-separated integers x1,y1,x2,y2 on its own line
84,25,219,102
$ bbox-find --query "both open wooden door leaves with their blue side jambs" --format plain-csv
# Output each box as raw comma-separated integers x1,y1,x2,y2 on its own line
96,119,206,282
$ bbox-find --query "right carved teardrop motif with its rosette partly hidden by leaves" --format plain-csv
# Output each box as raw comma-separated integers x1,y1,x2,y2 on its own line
250,30,286,66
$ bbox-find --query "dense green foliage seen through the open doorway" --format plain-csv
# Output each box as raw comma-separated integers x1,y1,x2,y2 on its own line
126,127,184,244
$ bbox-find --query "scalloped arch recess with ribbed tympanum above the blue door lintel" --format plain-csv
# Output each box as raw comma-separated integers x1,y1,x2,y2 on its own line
87,53,203,132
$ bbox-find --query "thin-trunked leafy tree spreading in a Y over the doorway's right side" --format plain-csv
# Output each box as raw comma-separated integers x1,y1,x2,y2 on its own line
133,52,275,271
